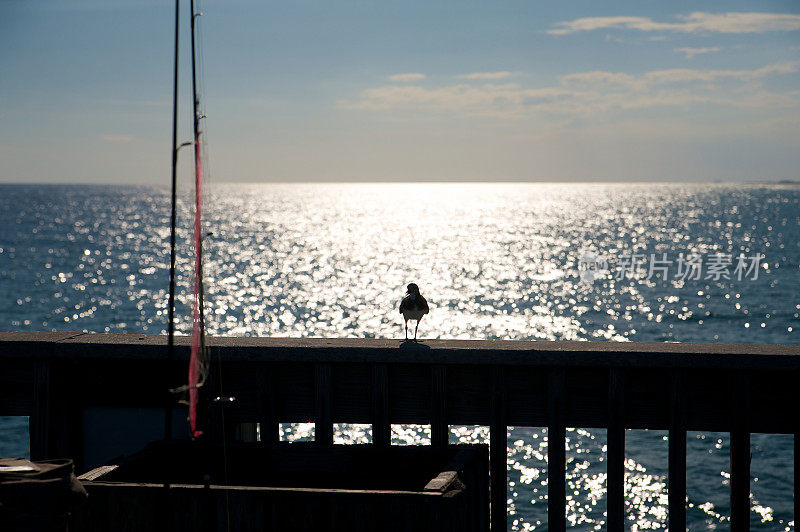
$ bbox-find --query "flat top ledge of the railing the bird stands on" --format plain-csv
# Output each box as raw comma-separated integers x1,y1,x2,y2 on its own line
0,332,800,370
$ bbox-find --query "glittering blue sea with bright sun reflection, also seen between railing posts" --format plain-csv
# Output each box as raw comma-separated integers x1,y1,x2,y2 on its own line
0,184,800,530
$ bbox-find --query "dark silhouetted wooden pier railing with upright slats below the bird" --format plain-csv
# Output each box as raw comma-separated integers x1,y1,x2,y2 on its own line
0,333,800,531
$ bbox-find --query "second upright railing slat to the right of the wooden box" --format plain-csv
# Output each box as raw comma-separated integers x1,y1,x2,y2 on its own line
547,368,567,532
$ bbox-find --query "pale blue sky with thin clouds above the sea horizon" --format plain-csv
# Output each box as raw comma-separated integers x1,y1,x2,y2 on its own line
0,0,800,184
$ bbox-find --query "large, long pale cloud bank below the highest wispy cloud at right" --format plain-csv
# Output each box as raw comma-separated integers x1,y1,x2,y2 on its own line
337,62,800,119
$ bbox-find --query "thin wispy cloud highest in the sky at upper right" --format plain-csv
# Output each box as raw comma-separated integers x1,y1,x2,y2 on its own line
547,12,800,35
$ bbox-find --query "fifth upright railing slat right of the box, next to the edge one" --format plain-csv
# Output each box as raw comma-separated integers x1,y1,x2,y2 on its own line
731,372,750,532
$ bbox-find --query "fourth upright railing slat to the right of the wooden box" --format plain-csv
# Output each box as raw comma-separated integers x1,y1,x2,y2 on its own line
667,370,686,531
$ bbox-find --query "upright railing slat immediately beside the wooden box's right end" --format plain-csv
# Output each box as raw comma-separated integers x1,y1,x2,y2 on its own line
489,367,508,532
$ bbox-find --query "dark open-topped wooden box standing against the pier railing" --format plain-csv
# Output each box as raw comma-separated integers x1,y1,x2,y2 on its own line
70,442,489,532
